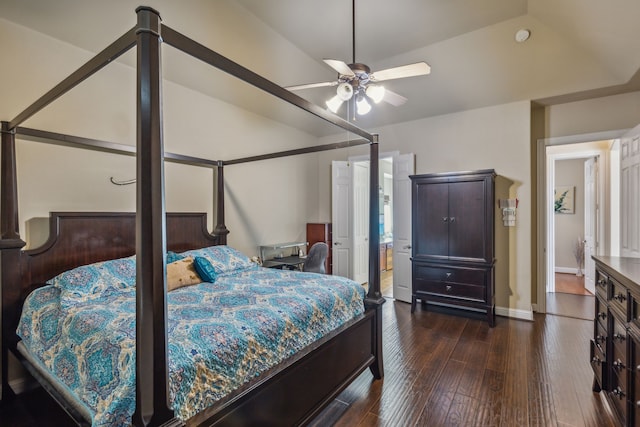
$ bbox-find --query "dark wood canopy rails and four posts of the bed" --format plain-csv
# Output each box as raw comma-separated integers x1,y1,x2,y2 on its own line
0,7,384,426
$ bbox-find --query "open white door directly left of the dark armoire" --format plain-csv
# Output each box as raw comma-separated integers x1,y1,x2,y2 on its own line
393,153,415,302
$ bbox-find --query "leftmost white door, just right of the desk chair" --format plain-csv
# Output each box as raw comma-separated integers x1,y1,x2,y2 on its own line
331,161,352,278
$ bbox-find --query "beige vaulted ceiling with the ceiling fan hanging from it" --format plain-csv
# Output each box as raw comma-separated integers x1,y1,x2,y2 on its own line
0,0,640,135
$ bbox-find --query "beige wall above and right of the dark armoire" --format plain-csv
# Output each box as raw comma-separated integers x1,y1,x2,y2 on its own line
320,102,532,317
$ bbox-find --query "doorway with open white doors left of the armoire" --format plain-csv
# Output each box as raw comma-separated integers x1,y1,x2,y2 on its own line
332,152,415,302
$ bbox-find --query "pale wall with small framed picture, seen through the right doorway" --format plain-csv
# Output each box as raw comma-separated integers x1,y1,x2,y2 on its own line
554,159,585,272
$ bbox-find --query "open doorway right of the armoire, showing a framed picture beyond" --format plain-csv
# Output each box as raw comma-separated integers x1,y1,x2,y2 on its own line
535,132,618,318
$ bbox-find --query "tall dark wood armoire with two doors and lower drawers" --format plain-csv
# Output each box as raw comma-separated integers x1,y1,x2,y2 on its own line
411,169,496,327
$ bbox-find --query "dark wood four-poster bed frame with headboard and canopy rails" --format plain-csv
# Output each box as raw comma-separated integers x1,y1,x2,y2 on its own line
0,7,385,426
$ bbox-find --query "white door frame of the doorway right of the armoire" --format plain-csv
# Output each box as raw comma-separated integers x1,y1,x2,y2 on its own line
533,129,629,313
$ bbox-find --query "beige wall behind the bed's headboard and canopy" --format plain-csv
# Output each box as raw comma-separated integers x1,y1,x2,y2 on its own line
0,20,319,255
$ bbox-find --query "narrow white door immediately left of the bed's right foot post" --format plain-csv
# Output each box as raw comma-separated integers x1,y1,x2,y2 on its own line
352,160,369,283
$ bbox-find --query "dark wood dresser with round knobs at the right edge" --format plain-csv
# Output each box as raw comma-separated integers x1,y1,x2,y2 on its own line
589,256,640,426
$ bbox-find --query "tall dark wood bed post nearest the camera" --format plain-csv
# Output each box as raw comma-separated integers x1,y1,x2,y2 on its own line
132,7,182,427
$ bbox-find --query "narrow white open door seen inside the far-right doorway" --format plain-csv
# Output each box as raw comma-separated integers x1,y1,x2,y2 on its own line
584,157,599,294
